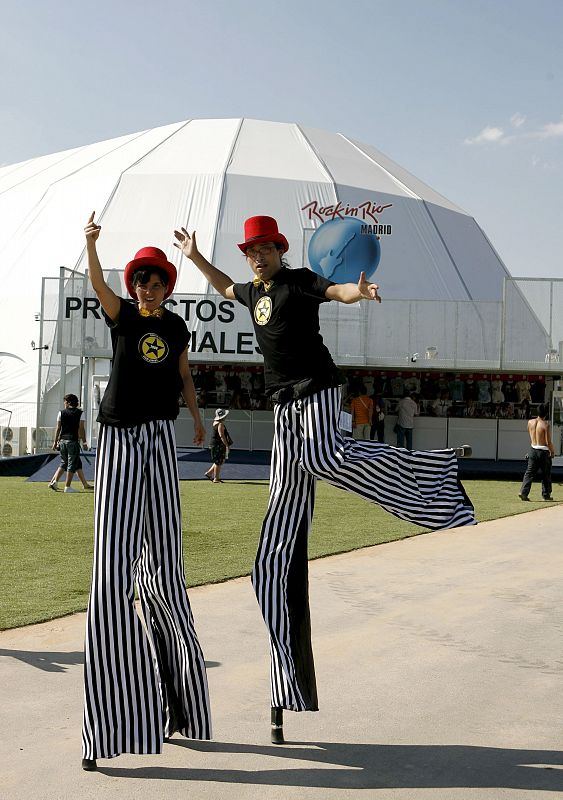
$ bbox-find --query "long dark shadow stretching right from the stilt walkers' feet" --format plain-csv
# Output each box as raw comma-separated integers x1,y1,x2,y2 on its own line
98,739,563,791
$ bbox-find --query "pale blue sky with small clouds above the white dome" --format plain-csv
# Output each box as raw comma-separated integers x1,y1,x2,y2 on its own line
0,0,563,278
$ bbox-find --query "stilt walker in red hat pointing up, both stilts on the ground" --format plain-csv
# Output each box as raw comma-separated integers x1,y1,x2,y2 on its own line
82,214,211,771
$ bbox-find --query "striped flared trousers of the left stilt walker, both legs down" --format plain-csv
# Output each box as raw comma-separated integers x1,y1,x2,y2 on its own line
82,420,211,759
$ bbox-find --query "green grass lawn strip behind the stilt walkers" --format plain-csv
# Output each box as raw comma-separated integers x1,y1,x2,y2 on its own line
0,478,562,629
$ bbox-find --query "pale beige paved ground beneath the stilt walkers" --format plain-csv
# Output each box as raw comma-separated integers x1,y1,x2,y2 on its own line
0,507,563,800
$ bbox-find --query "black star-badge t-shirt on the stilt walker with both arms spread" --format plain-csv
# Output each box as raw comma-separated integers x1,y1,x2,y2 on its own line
233,267,340,394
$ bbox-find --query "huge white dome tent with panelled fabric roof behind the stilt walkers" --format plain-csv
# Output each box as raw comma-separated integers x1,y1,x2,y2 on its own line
0,119,557,446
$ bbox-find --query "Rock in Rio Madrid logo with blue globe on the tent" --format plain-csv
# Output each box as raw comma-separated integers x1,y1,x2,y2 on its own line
301,200,393,283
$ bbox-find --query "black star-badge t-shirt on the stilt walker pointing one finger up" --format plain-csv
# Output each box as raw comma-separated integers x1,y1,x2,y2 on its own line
98,299,189,428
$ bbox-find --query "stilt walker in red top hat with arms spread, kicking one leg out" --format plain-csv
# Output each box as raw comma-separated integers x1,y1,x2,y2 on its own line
174,216,475,743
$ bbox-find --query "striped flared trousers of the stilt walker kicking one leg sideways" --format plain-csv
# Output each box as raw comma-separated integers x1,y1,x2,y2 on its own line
252,388,475,711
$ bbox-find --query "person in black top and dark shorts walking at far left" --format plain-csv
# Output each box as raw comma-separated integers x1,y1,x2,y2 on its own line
49,394,94,493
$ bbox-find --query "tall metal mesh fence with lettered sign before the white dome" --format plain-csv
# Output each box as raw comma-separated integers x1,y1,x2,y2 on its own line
22,269,563,444
